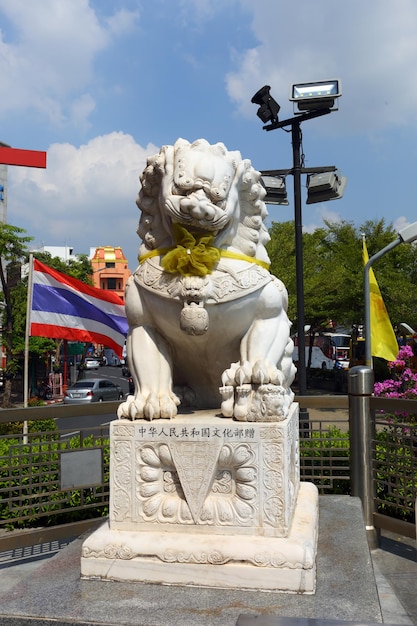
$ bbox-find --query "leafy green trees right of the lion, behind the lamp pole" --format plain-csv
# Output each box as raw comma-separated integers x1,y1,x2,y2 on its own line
268,220,417,329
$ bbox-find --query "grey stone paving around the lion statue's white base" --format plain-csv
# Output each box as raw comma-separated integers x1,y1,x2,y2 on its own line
0,496,417,626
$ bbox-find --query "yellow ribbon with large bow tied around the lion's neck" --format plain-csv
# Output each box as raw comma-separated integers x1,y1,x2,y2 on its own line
139,224,269,276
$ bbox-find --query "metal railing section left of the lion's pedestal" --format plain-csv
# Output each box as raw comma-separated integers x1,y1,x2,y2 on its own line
0,402,120,551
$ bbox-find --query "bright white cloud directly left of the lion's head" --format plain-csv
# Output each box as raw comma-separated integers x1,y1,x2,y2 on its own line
8,132,159,269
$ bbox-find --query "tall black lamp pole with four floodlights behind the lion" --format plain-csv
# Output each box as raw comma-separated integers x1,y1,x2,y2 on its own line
251,79,346,395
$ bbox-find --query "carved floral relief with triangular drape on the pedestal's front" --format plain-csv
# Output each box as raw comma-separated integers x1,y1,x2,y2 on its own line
135,442,258,526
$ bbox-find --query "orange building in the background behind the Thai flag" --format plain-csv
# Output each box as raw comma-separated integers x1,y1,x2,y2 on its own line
90,246,130,300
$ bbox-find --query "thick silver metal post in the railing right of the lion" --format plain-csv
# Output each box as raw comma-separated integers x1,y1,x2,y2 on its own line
348,365,378,548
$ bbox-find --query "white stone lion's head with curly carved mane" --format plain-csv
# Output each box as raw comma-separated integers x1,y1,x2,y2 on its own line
137,139,269,261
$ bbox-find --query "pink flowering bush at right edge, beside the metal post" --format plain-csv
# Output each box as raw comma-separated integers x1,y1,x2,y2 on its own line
374,346,417,422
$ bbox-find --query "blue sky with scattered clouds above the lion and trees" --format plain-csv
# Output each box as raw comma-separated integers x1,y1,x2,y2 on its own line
0,0,417,270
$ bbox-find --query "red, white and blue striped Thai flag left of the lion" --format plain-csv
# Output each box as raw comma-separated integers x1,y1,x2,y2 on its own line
29,259,128,357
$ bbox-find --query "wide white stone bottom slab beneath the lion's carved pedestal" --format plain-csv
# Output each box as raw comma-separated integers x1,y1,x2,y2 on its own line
81,483,318,594
